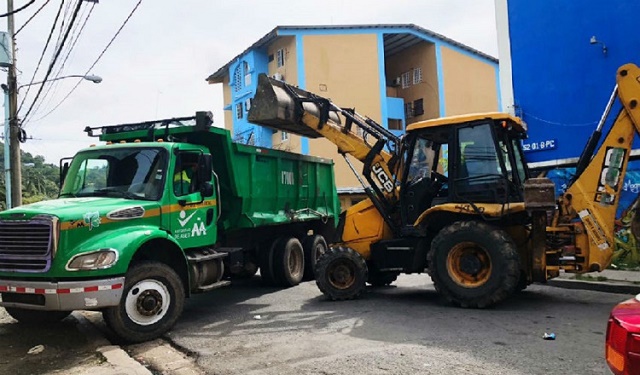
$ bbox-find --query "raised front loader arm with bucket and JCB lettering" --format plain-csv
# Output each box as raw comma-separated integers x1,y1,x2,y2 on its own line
248,74,400,216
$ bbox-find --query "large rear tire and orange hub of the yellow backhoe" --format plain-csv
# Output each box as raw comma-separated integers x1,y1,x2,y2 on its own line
428,221,520,308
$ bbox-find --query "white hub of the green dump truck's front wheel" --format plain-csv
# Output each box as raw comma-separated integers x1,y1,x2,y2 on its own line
125,279,171,326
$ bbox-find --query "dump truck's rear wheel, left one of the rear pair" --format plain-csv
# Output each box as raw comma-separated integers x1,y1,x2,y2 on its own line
273,237,304,288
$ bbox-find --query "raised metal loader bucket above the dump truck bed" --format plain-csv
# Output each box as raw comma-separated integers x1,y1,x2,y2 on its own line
248,74,340,138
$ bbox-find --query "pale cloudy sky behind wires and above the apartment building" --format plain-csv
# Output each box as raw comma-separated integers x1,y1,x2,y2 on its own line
0,0,498,164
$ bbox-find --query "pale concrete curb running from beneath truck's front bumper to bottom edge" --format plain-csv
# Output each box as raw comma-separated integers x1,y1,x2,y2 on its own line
72,312,153,375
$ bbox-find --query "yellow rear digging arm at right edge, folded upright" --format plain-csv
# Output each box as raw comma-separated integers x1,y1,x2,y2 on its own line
564,64,640,272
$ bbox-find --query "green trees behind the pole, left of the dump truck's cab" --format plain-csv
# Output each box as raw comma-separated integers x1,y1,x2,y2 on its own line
0,142,60,210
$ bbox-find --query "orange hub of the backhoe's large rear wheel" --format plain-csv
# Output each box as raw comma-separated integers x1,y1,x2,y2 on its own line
447,242,491,288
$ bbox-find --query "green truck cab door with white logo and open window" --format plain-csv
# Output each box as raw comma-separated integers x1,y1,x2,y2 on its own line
169,151,218,248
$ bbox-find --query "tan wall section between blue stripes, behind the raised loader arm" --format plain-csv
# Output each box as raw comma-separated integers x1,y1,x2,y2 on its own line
303,34,384,187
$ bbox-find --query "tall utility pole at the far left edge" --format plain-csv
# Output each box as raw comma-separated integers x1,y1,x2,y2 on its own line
5,0,22,207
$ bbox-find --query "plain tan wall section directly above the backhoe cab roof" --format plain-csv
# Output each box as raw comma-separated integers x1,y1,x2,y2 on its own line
440,46,499,116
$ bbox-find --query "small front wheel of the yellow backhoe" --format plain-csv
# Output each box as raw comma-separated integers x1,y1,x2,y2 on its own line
316,247,368,301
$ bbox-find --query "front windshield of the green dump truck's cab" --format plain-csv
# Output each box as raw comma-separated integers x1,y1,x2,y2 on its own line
60,148,167,200
